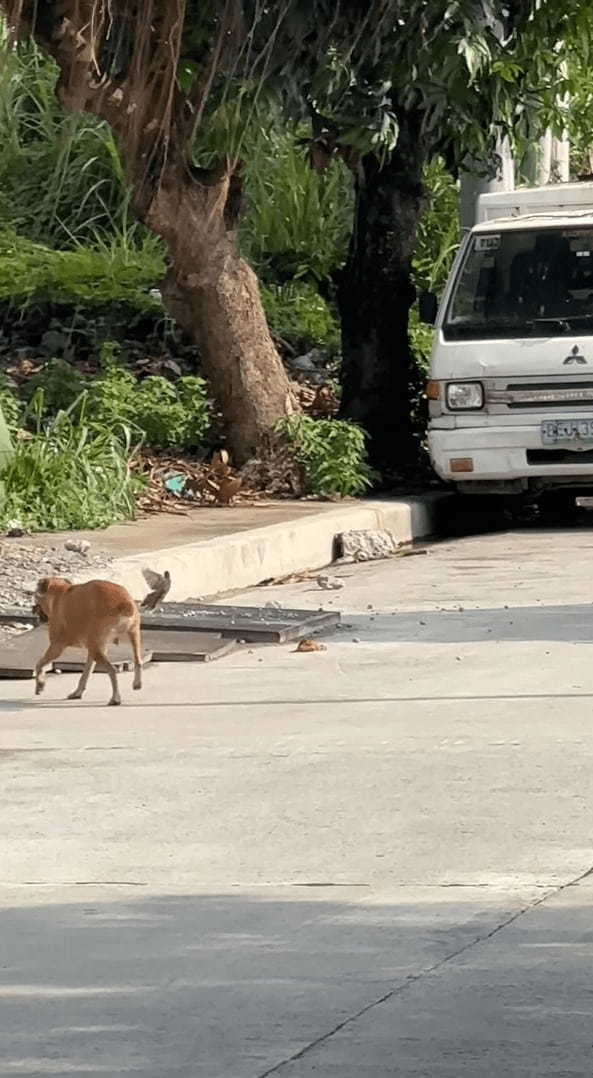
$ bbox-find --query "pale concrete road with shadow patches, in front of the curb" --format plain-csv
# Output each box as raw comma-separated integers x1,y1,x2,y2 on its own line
0,517,593,1078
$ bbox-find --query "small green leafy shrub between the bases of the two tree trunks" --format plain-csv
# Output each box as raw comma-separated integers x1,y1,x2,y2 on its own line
277,415,373,498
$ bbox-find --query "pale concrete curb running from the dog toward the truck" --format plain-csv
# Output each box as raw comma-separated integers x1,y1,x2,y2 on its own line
80,494,446,602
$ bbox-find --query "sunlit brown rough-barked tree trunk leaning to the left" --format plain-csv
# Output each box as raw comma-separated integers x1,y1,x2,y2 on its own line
144,167,297,465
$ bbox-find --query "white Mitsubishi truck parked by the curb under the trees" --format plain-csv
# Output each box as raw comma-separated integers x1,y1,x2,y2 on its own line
420,183,593,500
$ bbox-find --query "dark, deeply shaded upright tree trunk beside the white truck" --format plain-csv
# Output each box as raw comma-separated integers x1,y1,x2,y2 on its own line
339,116,425,474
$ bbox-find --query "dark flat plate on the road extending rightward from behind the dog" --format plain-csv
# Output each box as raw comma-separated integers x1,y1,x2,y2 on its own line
142,603,340,644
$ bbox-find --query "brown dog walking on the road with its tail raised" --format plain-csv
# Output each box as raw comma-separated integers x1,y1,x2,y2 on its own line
35,577,142,705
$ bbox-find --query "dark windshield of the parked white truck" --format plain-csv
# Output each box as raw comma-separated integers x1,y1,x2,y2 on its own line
443,227,593,338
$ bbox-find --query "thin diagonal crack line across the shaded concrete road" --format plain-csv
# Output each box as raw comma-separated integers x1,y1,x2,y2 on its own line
258,866,593,1078
